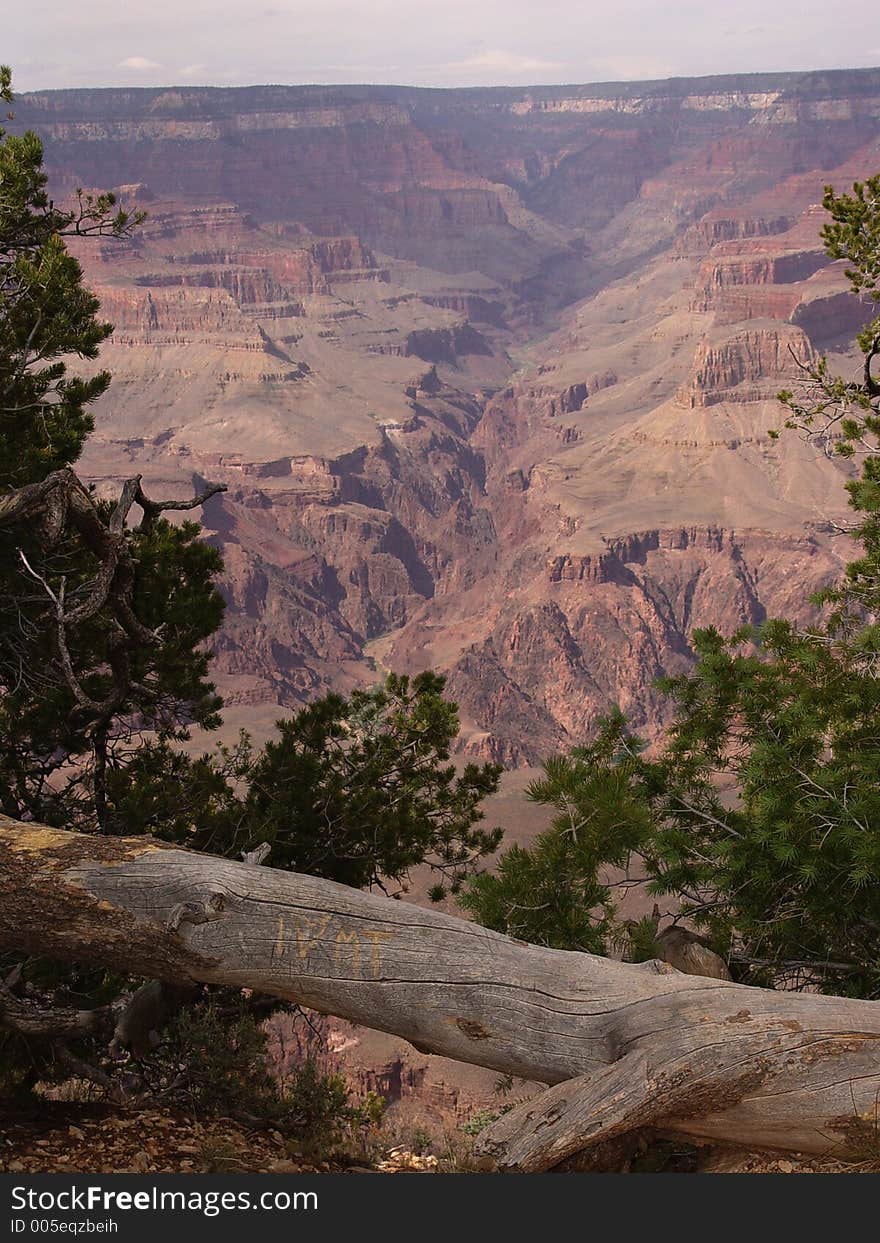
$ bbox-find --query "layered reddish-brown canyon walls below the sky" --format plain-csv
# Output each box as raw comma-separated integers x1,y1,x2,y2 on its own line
15,70,880,764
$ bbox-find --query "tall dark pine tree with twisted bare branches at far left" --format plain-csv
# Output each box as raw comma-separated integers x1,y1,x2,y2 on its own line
0,68,222,830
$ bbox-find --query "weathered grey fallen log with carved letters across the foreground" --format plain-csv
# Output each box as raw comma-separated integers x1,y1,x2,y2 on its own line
0,817,880,1170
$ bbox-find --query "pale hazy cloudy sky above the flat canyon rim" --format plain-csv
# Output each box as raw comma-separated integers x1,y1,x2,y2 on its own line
6,0,880,92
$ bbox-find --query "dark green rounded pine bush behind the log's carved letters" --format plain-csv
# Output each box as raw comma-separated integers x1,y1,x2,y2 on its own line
237,672,501,896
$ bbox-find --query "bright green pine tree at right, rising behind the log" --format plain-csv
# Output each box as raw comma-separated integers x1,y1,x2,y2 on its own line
465,177,880,997
